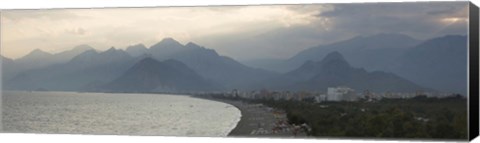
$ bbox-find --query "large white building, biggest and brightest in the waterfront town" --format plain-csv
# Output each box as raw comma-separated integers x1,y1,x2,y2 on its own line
327,87,357,101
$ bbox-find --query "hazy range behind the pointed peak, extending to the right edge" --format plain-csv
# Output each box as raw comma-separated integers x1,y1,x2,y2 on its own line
245,34,467,95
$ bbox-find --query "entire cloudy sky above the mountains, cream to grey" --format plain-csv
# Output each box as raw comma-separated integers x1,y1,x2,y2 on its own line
0,2,468,60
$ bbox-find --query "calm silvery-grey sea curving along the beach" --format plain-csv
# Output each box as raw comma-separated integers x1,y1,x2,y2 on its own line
2,91,241,136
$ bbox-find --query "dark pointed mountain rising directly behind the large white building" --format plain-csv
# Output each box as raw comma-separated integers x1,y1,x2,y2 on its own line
263,52,429,92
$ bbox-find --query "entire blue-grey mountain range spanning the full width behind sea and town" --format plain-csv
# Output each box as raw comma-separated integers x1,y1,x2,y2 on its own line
2,34,467,94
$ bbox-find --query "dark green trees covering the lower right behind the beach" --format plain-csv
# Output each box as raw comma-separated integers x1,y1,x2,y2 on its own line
215,95,468,139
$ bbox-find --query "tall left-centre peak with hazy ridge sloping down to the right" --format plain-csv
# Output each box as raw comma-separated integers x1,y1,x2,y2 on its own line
149,38,276,90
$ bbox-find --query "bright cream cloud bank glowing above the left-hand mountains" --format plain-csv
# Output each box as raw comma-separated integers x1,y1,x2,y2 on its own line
2,6,324,58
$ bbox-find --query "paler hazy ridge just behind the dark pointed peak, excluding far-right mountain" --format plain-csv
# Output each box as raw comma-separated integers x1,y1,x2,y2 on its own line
247,34,419,72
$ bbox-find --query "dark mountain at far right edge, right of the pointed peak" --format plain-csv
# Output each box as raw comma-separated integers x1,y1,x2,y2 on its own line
391,35,468,95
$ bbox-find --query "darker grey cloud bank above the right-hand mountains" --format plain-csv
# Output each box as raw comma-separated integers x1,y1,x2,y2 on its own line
200,2,468,61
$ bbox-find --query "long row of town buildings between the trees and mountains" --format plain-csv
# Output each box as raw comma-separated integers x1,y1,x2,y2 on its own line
223,86,455,103
